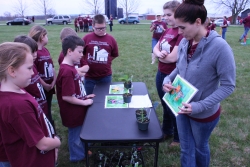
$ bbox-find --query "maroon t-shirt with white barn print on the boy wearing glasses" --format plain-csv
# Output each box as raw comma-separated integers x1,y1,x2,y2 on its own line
83,33,118,79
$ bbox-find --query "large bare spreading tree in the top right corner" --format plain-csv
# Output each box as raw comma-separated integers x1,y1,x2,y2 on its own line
213,0,250,24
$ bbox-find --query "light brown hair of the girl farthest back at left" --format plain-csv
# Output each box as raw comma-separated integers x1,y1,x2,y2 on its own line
29,25,47,42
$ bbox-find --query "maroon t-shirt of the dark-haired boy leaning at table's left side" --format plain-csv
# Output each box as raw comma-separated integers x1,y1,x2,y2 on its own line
56,64,87,128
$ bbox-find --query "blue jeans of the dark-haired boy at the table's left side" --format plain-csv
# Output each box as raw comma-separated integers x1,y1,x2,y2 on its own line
68,126,85,162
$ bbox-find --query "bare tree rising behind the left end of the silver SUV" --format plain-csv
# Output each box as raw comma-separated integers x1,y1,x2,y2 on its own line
34,0,55,24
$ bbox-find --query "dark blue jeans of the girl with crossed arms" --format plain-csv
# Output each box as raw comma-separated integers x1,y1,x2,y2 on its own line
156,70,179,142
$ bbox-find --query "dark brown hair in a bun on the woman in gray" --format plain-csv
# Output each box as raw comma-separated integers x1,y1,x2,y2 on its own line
174,0,207,24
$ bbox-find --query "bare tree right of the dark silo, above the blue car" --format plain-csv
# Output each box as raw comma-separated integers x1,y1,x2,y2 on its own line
118,0,140,23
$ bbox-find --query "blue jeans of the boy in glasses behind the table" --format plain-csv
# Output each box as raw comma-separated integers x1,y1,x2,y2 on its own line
84,75,112,95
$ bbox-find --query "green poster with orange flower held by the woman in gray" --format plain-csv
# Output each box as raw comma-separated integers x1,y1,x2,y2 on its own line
163,75,198,116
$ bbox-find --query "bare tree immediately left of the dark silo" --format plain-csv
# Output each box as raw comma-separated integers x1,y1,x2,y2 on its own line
83,0,104,15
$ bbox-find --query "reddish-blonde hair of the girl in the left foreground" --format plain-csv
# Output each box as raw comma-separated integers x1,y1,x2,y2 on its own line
0,42,31,81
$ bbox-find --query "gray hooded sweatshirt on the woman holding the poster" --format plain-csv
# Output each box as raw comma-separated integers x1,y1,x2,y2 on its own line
163,31,236,119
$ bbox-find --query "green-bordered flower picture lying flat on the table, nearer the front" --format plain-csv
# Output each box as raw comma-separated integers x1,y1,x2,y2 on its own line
105,95,128,108
